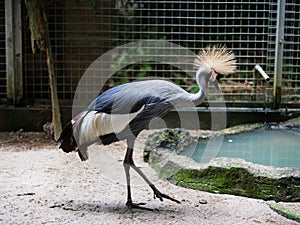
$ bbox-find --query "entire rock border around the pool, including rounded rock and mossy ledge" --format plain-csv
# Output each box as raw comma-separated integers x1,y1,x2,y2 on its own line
144,118,300,202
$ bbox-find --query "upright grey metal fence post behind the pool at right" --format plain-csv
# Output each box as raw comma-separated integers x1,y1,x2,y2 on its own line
273,0,285,109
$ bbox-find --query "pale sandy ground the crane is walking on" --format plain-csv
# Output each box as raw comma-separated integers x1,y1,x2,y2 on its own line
0,132,297,225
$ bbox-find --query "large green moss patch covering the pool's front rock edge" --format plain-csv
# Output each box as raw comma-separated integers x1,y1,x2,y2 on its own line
172,166,300,201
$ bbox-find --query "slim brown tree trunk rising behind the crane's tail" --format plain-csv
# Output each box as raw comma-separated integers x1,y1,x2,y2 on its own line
25,0,62,140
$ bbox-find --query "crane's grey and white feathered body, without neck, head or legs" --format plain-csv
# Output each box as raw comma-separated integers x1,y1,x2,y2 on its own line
69,80,199,151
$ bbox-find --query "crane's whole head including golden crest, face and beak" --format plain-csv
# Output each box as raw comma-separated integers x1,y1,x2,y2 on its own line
194,46,236,91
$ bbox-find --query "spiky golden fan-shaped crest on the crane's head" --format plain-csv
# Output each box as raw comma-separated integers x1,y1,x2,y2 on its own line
194,46,236,75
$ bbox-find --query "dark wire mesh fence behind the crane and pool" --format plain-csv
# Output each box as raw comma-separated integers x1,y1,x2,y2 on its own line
0,0,300,106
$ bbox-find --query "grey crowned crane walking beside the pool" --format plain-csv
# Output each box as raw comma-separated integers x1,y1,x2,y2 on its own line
58,46,236,209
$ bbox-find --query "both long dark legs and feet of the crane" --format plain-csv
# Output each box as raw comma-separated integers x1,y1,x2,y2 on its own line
123,140,181,210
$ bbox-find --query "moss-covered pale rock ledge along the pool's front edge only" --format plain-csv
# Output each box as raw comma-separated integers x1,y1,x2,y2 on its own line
149,152,300,202
